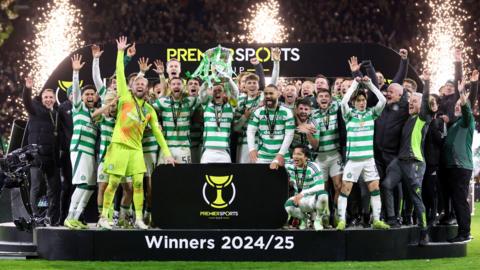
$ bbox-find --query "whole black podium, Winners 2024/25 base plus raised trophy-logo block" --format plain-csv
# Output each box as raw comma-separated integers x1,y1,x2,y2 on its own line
0,164,467,261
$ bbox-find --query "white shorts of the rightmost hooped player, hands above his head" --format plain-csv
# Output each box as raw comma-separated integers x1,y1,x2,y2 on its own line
342,158,380,183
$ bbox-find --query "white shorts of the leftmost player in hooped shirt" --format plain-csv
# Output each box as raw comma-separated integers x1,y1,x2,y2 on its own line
70,151,97,186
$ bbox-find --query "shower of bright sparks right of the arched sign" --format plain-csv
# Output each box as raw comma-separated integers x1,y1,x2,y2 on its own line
417,0,473,92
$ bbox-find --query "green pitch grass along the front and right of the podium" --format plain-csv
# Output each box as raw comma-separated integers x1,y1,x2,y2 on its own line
0,203,480,270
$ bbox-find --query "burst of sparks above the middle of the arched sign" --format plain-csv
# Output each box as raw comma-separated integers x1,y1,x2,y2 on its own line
234,0,293,43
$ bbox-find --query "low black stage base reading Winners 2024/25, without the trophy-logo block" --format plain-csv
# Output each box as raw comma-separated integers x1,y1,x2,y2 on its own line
0,223,467,261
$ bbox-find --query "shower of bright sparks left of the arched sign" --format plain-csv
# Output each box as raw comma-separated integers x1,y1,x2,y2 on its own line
21,0,84,91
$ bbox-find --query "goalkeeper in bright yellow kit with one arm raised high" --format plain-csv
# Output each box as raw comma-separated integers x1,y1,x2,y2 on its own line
98,37,175,229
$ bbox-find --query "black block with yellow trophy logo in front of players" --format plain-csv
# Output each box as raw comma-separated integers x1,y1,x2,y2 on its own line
152,164,288,229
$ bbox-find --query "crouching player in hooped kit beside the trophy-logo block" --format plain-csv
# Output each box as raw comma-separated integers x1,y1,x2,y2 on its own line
285,145,330,231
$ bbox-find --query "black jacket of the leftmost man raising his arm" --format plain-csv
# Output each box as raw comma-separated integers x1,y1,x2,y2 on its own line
23,88,60,161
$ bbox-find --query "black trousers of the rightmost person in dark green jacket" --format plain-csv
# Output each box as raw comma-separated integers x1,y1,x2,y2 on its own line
445,168,472,236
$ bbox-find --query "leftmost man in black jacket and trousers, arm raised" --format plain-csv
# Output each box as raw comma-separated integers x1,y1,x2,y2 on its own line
23,78,60,225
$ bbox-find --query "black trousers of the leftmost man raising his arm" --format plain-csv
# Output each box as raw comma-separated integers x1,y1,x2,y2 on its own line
30,162,60,224
